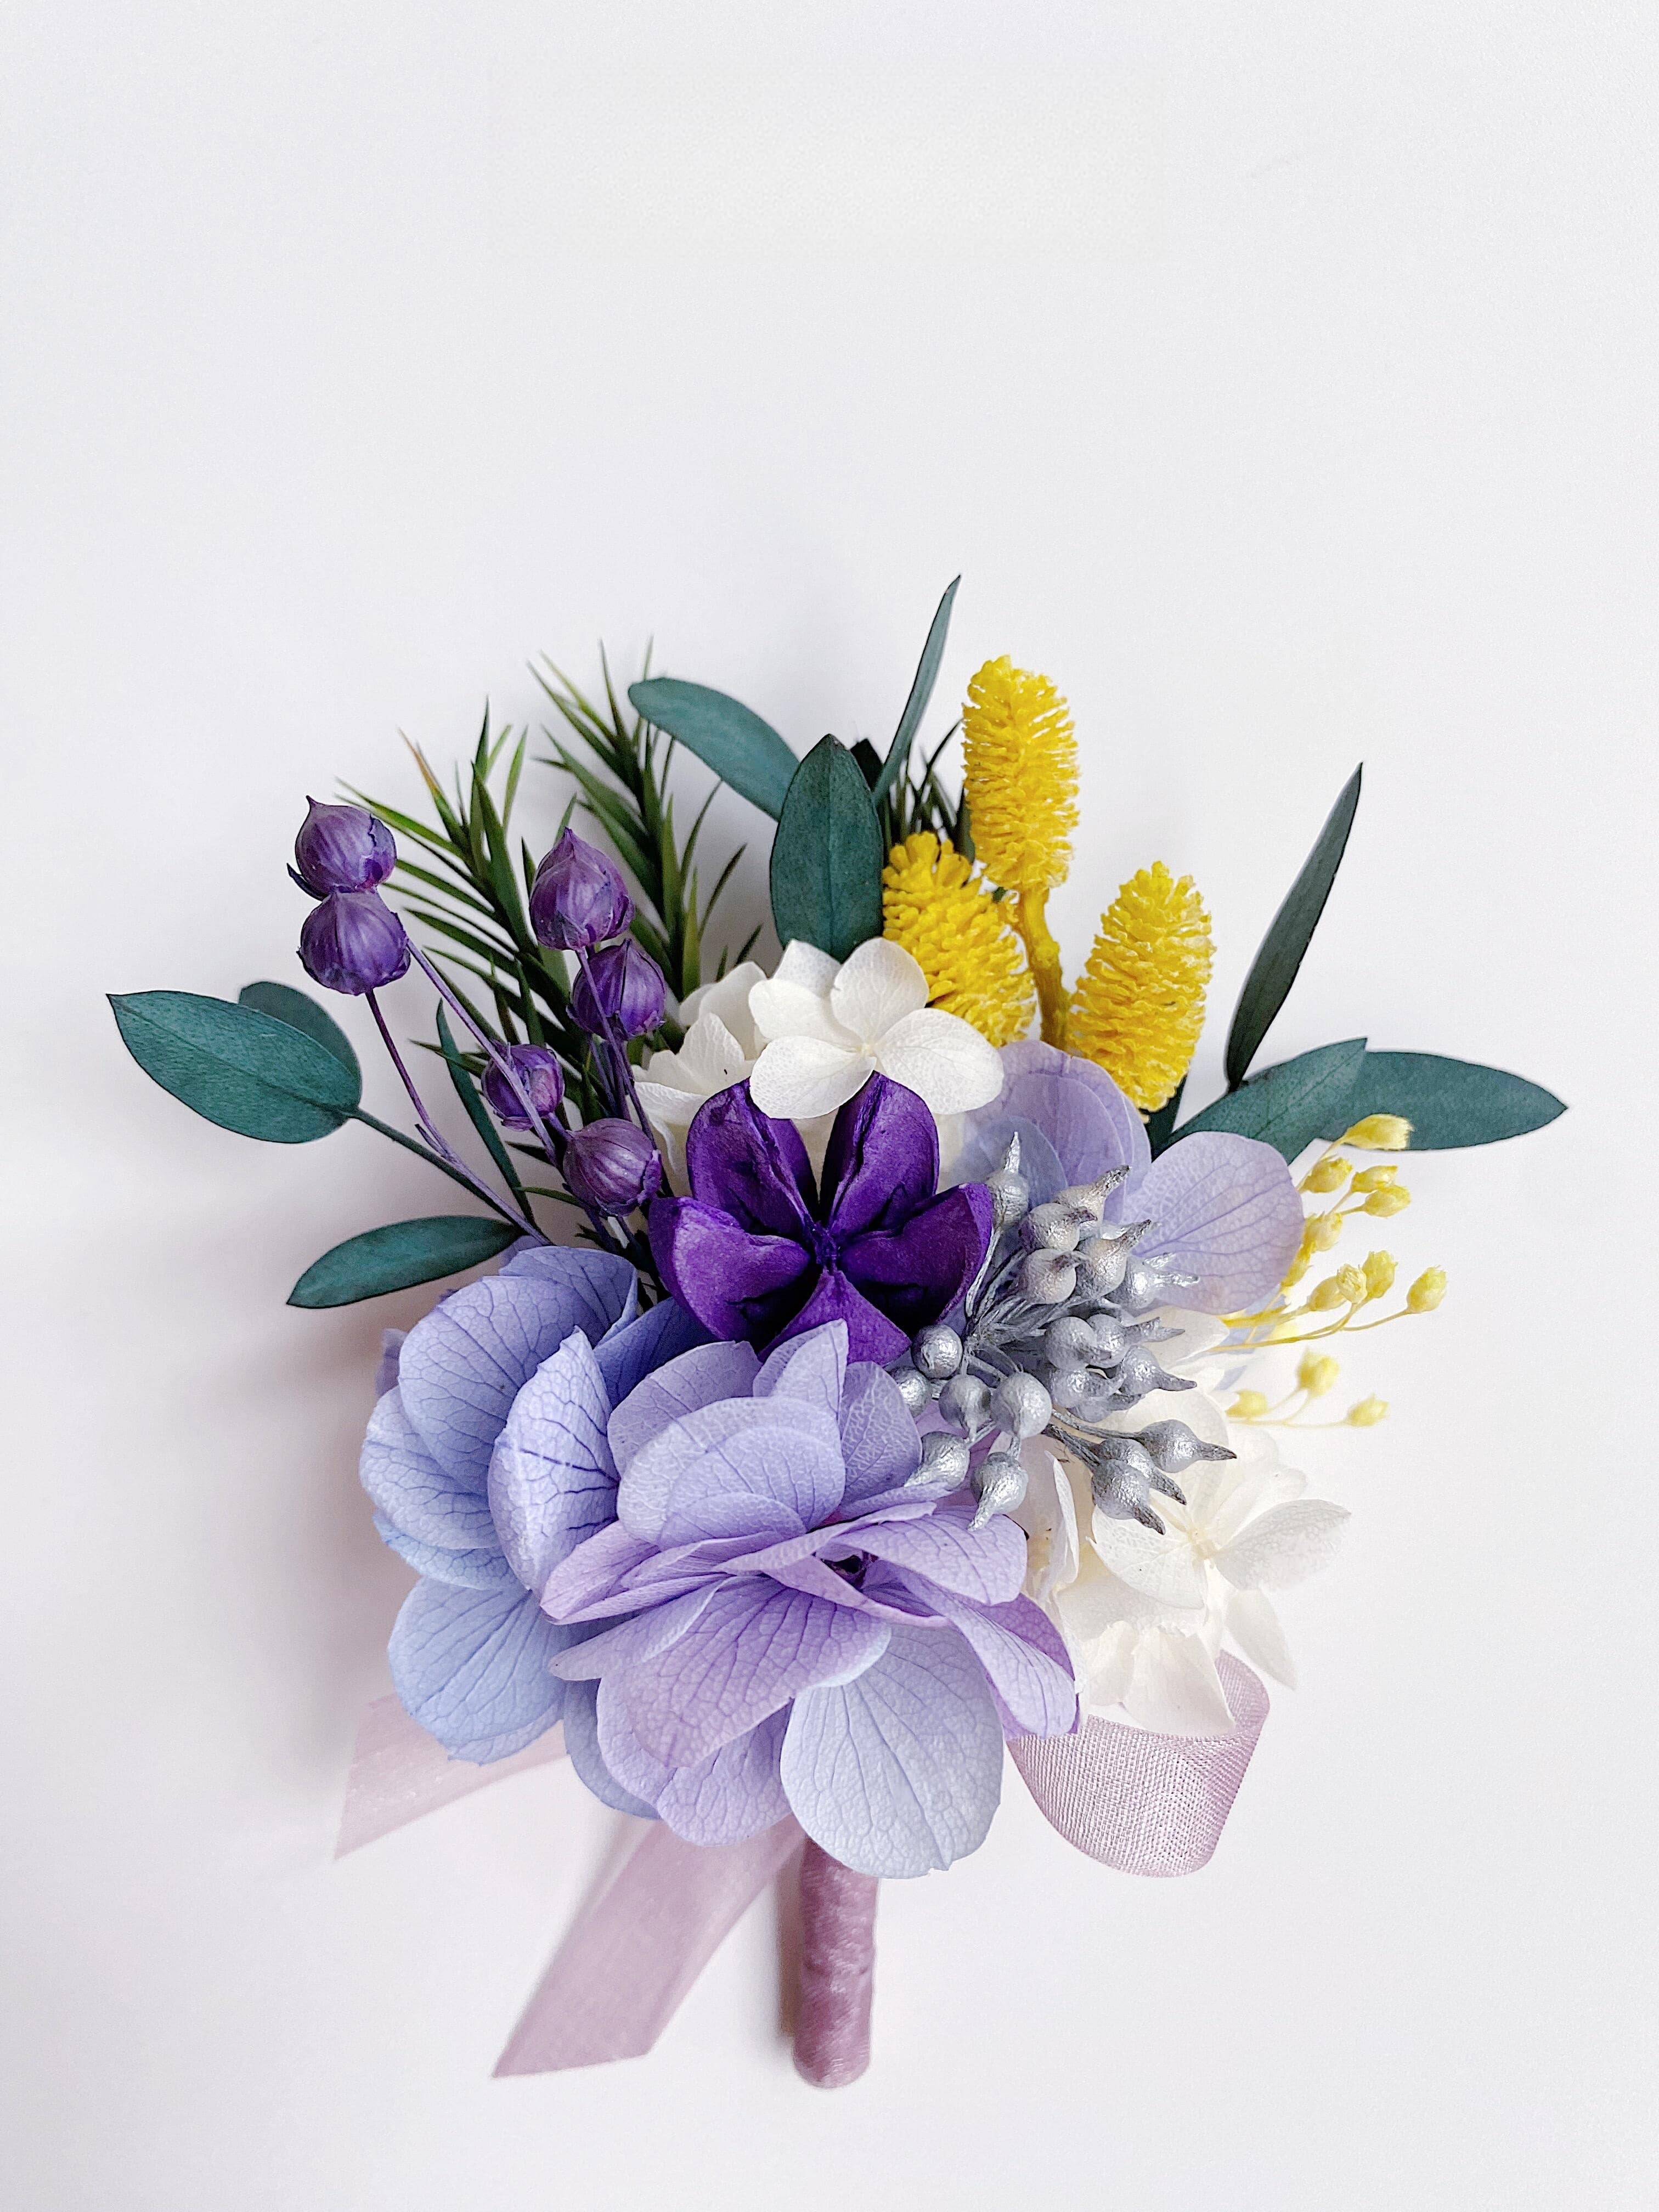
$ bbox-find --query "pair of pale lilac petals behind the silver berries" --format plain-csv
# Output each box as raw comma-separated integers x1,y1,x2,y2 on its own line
956,1040,1303,1314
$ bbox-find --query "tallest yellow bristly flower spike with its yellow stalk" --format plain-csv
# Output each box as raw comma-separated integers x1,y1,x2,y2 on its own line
962,652,1077,1044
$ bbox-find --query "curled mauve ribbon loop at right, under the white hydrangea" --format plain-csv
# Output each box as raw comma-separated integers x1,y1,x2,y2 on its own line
1009,1652,1267,1876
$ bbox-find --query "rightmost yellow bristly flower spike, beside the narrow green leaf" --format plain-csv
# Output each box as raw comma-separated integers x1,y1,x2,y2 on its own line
1070,858,1215,1113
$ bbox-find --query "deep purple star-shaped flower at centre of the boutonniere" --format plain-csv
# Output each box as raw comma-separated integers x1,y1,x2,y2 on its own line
650,1075,991,1363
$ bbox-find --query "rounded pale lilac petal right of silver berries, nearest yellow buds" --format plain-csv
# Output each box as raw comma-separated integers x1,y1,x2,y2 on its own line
1130,1130,1303,1314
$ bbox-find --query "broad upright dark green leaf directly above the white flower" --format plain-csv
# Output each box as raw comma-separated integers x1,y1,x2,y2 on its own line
772,737,883,960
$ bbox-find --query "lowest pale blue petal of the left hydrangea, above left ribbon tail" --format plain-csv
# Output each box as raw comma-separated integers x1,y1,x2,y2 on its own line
387,1582,579,1765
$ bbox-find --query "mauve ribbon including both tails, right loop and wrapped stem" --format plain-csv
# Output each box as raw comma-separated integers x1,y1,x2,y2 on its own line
334,1652,1267,2088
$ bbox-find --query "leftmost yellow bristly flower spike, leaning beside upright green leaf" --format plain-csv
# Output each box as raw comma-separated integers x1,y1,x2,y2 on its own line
881,830,1033,1044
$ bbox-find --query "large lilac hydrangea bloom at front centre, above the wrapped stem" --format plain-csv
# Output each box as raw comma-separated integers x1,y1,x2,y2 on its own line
548,1321,1077,1876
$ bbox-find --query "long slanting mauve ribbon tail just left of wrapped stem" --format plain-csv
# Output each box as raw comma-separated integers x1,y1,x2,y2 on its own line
495,1820,801,2075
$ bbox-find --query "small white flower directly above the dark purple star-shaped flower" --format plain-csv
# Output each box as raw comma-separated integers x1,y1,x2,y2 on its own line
750,938,1002,1139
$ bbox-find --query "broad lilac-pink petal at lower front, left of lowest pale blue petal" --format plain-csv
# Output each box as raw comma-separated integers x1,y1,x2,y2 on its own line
614,1577,889,1768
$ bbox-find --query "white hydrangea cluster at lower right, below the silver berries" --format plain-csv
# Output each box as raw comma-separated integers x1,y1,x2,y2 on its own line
1018,1312,1350,1736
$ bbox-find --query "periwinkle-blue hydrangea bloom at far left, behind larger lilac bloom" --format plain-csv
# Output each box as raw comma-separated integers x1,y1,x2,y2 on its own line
360,1243,703,1765
